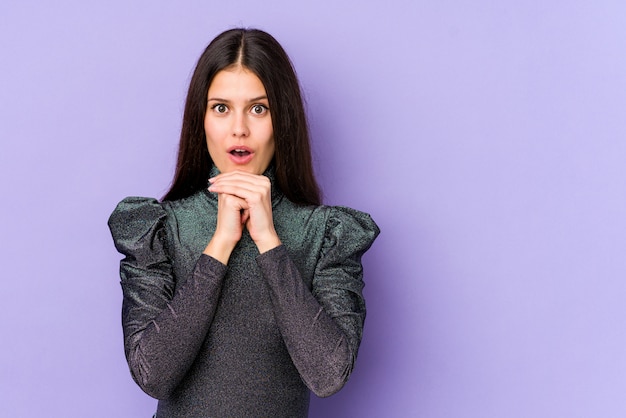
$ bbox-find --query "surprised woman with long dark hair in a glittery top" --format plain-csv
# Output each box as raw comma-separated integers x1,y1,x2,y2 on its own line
109,29,379,417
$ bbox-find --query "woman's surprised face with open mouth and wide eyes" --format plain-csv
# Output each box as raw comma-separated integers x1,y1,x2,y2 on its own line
204,67,274,174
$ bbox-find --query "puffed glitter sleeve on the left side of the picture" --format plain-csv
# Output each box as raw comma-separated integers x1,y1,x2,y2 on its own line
108,197,226,399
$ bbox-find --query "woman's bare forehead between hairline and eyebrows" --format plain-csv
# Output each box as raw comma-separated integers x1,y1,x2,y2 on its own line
208,67,266,99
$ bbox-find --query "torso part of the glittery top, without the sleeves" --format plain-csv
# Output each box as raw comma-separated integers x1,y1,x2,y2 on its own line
158,191,328,417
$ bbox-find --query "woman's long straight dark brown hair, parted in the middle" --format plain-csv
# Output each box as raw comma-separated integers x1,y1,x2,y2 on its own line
163,29,321,205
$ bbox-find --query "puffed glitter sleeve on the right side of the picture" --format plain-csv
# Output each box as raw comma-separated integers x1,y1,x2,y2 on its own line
257,207,380,397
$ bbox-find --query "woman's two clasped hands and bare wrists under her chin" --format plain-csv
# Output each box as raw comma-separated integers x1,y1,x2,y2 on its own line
204,171,281,264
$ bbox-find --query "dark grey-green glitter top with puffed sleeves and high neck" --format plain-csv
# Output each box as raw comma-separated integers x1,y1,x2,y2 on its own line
109,168,379,418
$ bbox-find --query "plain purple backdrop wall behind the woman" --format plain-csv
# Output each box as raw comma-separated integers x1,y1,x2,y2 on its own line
0,0,626,418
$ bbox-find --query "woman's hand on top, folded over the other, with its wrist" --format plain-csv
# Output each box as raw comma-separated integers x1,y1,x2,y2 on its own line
209,171,281,254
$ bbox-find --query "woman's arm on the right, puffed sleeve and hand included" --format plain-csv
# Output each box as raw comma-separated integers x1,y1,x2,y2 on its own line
207,176,379,396
